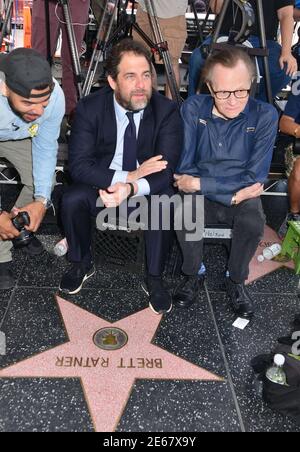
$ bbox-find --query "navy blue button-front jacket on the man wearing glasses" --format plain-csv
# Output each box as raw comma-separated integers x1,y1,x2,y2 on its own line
177,95,278,206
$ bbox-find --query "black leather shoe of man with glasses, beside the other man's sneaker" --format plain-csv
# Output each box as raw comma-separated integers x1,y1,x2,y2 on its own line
173,275,205,309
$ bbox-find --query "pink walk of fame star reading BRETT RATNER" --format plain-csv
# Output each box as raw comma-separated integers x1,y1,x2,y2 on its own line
0,297,223,432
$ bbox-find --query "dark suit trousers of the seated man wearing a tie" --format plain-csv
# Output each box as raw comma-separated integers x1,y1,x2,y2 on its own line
62,184,173,276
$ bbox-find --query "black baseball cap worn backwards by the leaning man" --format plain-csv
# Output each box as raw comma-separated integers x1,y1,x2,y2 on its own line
0,48,54,99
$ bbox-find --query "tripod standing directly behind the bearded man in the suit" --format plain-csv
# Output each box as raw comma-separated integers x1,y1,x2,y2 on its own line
83,0,182,106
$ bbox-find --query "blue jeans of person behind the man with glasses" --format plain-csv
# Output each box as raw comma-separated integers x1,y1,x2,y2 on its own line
189,36,291,101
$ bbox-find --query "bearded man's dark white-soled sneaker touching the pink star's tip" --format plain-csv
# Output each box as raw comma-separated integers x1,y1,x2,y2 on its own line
142,276,173,315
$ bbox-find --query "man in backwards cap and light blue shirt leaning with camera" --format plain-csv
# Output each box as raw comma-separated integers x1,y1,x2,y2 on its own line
0,48,65,289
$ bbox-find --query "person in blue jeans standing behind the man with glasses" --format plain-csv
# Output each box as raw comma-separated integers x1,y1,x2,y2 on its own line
189,0,297,101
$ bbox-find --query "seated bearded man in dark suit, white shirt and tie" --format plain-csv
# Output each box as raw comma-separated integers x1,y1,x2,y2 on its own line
60,40,183,314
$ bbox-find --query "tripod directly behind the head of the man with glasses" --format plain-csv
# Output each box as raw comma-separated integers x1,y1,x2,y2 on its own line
211,0,273,104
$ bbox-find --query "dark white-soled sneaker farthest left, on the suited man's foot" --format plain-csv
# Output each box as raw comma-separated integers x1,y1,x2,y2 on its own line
59,264,96,295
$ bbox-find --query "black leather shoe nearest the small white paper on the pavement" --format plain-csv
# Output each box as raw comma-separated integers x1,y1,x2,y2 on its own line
226,278,254,318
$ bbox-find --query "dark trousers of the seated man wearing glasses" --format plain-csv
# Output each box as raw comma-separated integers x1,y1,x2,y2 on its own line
175,195,265,283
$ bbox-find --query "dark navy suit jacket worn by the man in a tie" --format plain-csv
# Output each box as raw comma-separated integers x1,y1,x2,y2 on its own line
69,88,183,195
